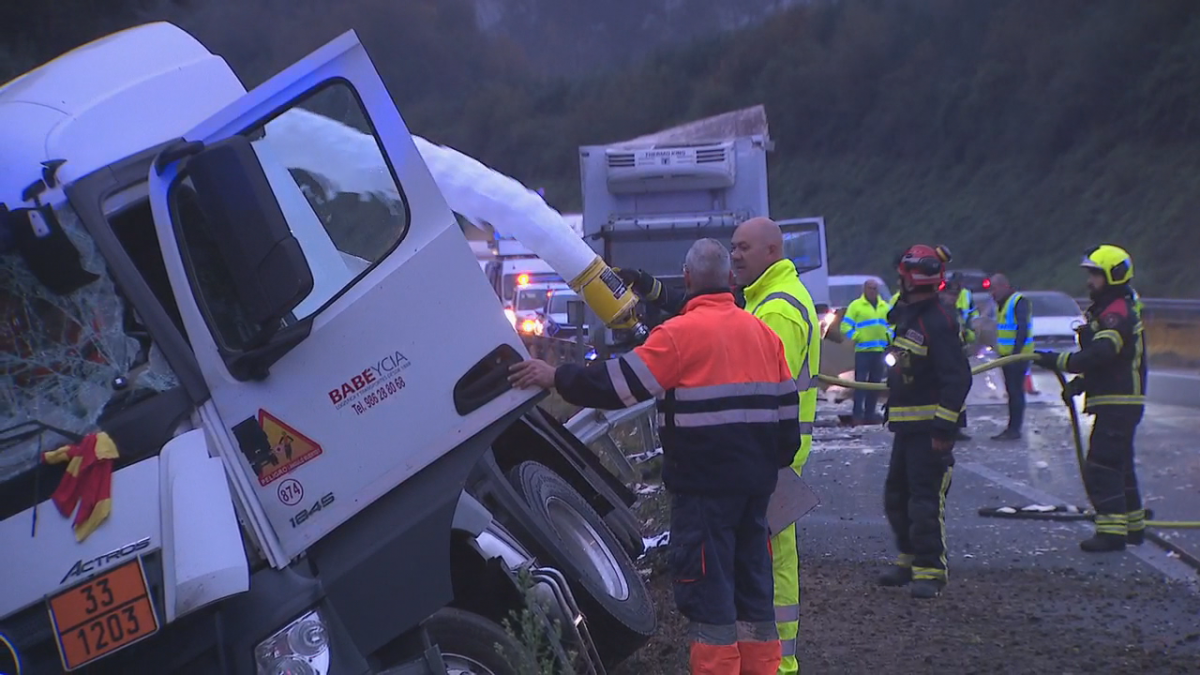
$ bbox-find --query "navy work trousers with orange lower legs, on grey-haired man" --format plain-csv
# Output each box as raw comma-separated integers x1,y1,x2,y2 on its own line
668,494,781,675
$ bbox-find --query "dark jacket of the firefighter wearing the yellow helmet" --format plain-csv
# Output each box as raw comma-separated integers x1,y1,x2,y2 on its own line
1057,286,1146,412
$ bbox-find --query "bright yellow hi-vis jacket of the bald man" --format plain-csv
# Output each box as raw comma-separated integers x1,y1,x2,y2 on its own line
745,258,821,470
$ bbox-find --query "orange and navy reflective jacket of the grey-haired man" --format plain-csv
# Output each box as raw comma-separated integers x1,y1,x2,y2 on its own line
554,289,800,495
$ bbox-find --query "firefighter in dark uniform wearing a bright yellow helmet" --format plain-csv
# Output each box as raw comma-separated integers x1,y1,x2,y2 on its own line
1037,244,1146,552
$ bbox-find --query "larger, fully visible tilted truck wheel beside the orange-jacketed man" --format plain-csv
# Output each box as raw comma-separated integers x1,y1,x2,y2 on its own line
509,461,656,667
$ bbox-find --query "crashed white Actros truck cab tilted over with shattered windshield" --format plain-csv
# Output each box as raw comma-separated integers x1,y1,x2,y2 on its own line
0,24,654,675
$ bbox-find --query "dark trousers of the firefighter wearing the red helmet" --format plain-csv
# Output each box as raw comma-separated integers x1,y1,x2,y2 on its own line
883,432,954,581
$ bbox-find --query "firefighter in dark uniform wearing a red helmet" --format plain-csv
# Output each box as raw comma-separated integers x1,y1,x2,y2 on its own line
880,244,971,598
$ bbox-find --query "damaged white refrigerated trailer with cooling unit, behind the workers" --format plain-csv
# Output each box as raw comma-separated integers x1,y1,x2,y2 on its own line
580,106,829,329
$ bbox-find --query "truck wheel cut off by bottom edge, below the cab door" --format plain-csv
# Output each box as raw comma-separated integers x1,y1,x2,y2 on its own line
425,608,529,675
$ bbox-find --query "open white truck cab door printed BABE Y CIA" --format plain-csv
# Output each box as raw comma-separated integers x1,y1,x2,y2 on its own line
150,31,534,567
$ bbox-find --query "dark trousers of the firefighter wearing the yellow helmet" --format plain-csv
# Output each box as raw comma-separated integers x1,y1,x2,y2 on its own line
1084,405,1145,536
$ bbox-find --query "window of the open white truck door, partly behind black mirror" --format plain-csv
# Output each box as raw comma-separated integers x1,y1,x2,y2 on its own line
170,80,409,350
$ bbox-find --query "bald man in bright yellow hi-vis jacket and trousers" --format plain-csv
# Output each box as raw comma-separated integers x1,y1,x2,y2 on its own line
730,217,821,675
